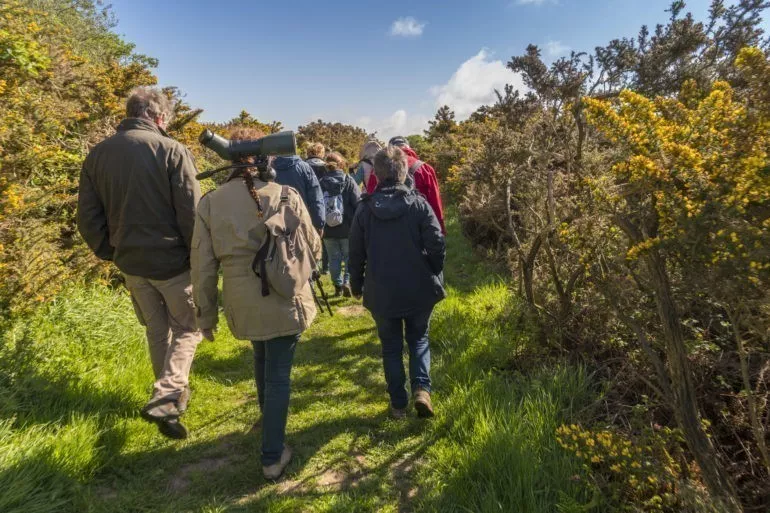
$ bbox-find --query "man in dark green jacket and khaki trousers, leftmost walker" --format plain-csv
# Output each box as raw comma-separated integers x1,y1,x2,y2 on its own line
77,87,202,438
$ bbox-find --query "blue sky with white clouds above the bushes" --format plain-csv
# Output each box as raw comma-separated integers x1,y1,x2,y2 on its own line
112,0,728,137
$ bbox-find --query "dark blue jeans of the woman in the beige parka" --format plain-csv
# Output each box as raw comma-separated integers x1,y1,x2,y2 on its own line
252,334,299,466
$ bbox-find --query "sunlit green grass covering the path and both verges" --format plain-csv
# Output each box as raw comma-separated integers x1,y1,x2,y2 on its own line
0,210,592,513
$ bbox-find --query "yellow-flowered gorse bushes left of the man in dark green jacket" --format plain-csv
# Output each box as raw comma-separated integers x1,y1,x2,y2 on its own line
0,0,160,312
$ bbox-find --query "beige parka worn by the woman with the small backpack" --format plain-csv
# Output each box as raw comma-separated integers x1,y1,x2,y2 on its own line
190,177,321,340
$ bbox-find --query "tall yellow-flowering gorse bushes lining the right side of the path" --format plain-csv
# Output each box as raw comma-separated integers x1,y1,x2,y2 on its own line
415,0,770,511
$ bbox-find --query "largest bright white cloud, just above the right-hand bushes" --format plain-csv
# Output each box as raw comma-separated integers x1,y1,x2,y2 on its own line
430,49,525,120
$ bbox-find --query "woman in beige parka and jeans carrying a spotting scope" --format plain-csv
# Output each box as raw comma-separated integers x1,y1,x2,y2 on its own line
191,128,321,479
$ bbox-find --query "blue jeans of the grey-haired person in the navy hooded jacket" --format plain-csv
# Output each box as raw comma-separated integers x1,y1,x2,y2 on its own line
374,309,433,409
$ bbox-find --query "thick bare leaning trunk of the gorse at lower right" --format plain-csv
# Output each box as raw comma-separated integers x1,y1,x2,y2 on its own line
645,249,743,513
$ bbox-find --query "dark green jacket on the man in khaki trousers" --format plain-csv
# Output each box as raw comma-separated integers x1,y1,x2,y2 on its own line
77,118,200,280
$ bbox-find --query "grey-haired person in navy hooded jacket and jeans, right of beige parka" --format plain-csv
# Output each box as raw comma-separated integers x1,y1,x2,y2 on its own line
350,146,446,418
